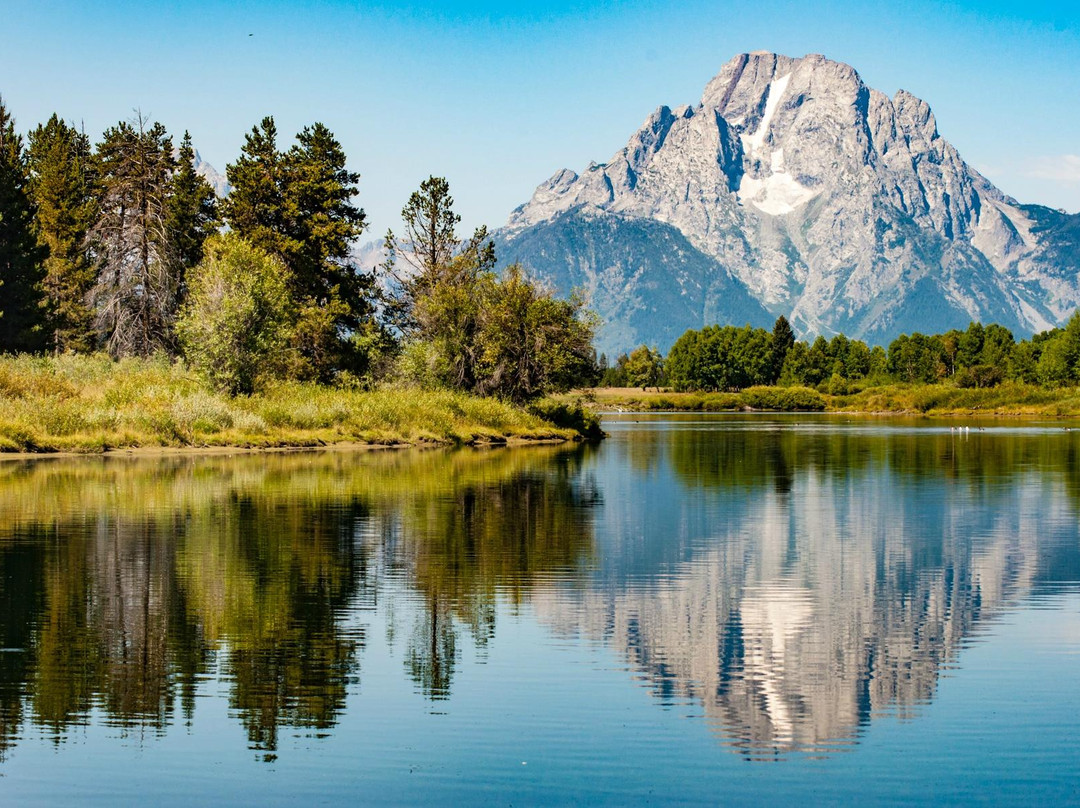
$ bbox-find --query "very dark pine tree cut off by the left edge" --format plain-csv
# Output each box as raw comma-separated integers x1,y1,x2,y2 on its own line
0,98,48,351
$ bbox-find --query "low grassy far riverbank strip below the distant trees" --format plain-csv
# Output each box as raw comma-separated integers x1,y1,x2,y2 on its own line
576,382,1080,417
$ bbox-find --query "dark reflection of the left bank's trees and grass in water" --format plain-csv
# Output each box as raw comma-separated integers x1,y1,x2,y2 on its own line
0,448,597,758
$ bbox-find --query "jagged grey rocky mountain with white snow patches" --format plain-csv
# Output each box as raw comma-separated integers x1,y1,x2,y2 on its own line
498,53,1080,349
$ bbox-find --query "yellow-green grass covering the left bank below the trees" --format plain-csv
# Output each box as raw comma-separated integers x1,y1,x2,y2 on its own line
0,355,579,453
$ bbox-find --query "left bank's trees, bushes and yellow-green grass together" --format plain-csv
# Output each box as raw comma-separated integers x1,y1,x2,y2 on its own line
0,107,603,454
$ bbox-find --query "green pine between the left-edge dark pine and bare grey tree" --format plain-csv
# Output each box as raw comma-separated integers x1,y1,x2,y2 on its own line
27,115,94,351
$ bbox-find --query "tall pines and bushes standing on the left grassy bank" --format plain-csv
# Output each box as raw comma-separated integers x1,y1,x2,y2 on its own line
0,99,596,402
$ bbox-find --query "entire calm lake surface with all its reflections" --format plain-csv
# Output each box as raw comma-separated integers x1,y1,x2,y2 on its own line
0,415,1080,805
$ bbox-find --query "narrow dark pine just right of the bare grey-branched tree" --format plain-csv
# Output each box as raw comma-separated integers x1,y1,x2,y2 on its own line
165,132,218,277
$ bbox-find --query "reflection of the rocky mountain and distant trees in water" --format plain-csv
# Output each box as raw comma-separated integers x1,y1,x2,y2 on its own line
539,419,1080,758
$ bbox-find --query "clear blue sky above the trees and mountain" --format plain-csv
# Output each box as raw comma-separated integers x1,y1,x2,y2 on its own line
0,0,1080,238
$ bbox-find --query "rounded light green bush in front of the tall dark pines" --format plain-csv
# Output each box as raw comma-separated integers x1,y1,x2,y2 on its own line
176,233,295,395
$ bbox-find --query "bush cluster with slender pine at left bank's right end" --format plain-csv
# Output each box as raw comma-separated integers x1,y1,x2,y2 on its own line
382,177,595,402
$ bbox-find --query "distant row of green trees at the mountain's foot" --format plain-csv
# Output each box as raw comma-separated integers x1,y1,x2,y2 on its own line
600,312,1080,394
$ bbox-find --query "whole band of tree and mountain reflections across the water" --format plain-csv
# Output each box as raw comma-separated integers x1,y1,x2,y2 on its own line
0,417,1080,758
